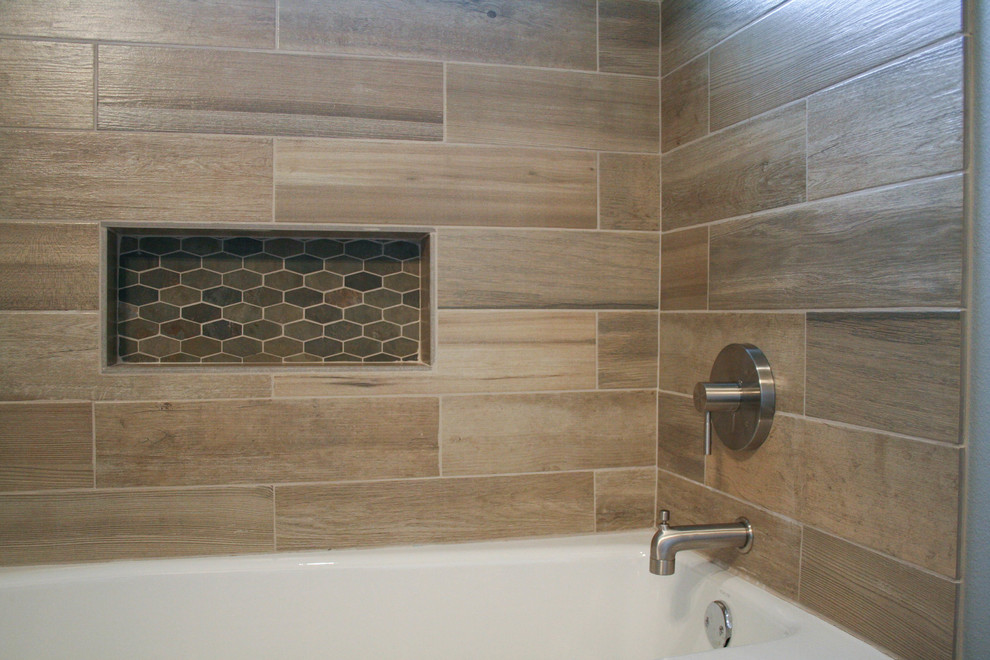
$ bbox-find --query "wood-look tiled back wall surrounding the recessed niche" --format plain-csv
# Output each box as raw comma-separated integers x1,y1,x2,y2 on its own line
0,0,660,564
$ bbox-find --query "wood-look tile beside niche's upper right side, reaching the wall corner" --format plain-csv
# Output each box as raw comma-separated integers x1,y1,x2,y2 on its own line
437,228,660,309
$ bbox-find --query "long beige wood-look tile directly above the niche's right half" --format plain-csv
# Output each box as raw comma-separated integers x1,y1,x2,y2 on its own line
275,139,597,229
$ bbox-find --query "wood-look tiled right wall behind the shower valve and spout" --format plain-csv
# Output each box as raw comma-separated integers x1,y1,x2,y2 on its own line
657,0,967,659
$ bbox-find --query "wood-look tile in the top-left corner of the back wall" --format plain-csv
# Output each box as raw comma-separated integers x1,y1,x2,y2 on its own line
0,0,275,48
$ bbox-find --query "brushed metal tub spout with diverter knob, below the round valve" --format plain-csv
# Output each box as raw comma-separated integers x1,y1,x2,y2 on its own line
650,509,753,575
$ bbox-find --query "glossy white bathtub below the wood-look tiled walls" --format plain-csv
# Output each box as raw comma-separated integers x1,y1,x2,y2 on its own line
0,532,887,660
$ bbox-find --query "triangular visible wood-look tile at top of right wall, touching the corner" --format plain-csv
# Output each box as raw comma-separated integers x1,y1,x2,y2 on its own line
660,0,784,75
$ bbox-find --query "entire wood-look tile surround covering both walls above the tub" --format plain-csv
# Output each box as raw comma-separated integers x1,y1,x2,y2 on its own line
0,0,966,658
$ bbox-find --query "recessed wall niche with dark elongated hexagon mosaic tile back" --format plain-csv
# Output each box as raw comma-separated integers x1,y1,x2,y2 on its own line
105,227,431,367
